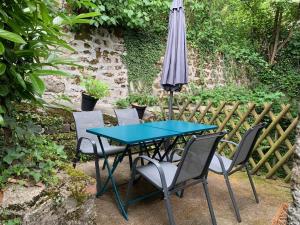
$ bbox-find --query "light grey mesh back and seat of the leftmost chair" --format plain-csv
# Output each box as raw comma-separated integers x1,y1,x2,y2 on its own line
73,111,109,153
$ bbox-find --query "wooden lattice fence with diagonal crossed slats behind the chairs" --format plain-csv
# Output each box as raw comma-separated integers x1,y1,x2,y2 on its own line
160,99,299,182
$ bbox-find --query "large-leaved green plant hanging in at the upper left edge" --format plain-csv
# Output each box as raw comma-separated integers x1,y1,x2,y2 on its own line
0,0,99,126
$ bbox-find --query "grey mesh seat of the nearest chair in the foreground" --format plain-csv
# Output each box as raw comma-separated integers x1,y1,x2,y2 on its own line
136,162,177,189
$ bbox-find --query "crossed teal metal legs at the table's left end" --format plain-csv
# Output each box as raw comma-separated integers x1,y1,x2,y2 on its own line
97,137,128,220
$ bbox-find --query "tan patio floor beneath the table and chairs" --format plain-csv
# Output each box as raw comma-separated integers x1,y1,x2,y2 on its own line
77,160,291,225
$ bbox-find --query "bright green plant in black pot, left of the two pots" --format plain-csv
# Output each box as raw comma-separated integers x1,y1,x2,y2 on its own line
81,76,109,111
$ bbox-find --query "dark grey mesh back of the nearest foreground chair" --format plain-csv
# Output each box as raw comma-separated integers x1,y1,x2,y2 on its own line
172,132,225,185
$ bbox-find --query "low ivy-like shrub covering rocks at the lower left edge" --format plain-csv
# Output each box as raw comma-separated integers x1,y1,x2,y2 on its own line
0,136,67,188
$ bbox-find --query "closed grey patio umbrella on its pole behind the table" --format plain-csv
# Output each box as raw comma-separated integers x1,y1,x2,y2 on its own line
161,0,188,119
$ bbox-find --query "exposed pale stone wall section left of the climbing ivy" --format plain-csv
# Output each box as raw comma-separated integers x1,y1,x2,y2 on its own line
44,28,128,107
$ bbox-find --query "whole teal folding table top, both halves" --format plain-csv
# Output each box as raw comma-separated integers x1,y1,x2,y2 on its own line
87,120,217,144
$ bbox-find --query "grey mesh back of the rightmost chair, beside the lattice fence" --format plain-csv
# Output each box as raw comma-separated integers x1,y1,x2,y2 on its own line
232,123,266,166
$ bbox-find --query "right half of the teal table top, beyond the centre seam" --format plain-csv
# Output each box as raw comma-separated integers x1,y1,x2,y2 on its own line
144,120,218,135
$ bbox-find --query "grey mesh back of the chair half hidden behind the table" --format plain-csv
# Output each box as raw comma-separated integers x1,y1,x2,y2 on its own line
115,109,140,125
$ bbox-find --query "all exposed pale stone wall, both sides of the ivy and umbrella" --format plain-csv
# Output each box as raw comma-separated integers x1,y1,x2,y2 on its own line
45,28,249,107
